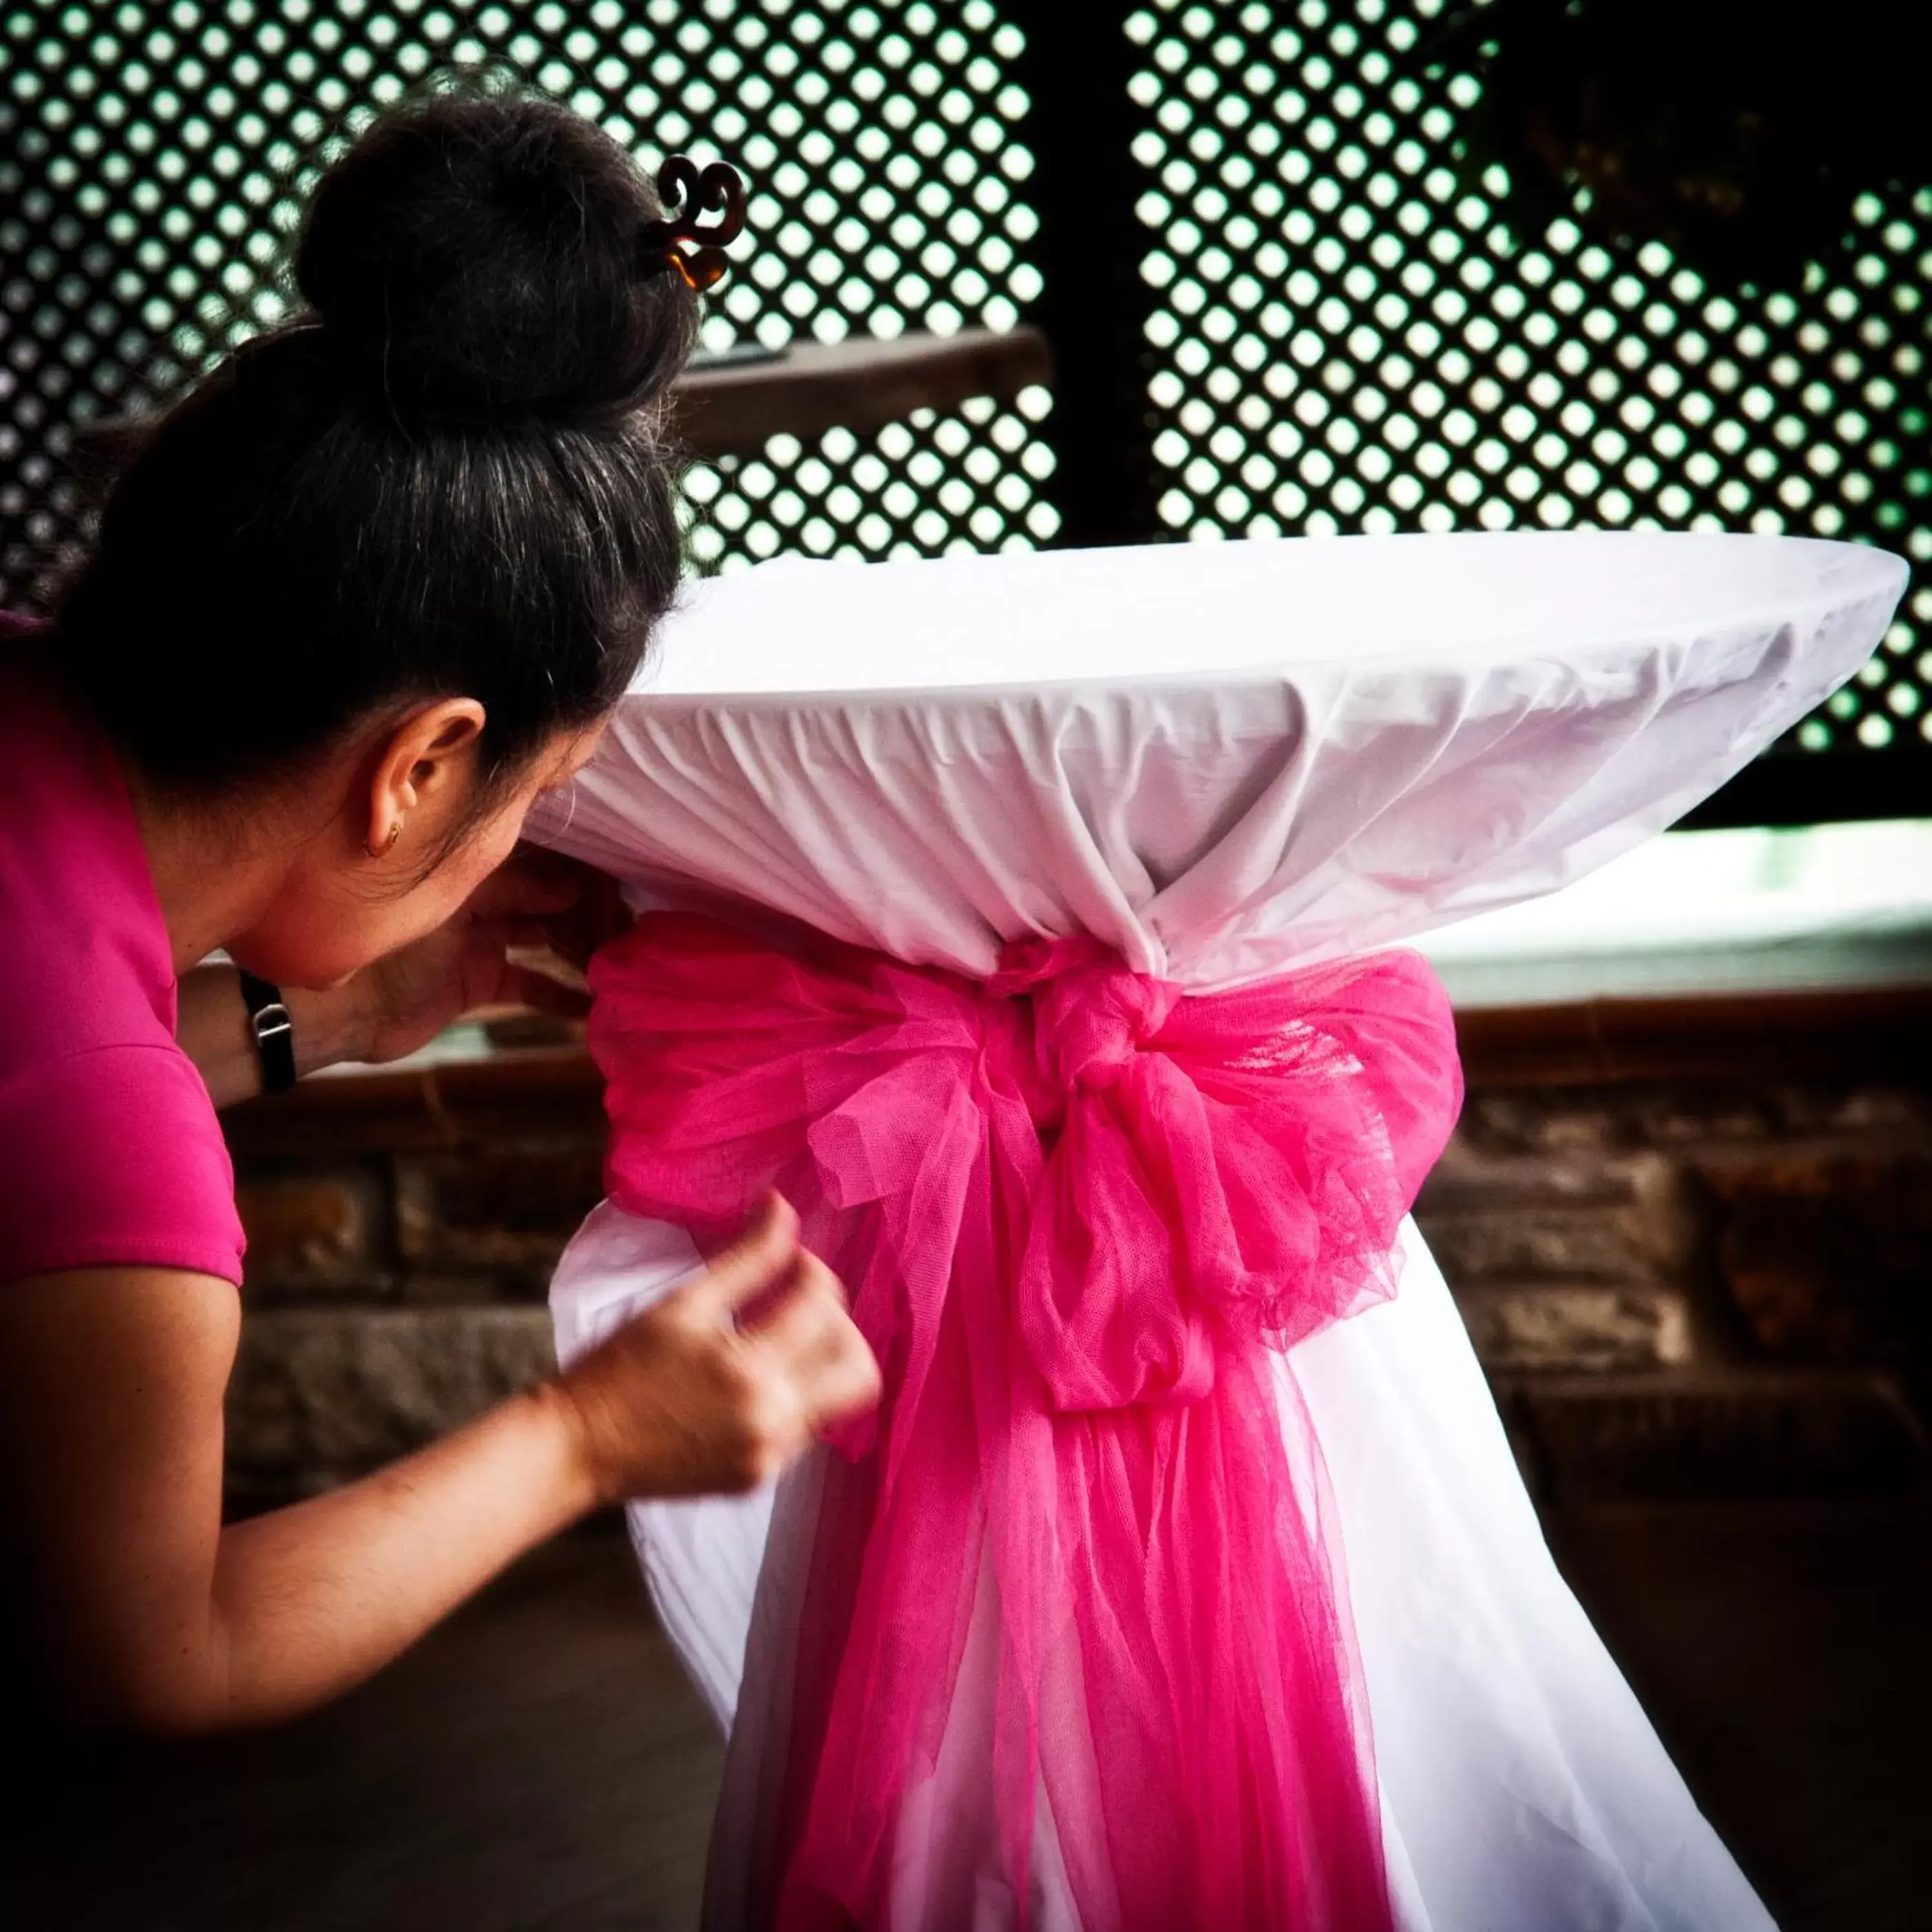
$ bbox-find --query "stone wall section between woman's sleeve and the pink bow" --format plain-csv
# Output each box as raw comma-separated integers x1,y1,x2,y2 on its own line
226,1051,603,1507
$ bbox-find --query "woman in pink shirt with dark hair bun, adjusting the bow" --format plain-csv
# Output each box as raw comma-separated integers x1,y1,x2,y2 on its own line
0,94,877,1733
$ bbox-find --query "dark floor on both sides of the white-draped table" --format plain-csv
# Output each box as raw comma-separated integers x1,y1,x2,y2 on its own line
0,1505,1932,1932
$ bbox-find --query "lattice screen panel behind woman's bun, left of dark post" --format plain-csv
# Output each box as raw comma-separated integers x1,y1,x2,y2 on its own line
0,0,1057,595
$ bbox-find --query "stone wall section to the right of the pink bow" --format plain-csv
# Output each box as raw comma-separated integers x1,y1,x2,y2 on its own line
1416,1074,1932,1499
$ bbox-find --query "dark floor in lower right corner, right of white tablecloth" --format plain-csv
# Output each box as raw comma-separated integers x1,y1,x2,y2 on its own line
1546,1503,1932,1932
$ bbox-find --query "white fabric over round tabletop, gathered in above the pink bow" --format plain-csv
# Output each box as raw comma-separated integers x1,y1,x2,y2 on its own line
532,533,1905,989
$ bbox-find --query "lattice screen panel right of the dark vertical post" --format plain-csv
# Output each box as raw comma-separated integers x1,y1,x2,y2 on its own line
1128,0,1932,749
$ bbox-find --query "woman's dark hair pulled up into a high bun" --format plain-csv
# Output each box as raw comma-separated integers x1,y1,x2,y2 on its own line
54,91,698,792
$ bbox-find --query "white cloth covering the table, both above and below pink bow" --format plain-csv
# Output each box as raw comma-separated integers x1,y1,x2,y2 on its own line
532,533,1905,1932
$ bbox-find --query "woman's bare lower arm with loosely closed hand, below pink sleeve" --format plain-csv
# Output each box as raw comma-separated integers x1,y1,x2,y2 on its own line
0,1196,877,1735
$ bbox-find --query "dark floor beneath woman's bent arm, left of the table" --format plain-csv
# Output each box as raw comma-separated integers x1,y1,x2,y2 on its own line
0,1530,723,1932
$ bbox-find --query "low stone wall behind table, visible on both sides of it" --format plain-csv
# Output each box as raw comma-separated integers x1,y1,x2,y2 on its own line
219,1009,1932,1507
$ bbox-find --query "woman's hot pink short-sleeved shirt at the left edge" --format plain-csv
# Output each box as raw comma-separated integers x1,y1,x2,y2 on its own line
0,612,243,1283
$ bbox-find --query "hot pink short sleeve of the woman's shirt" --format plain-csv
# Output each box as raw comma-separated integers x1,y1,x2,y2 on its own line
0,1043,243,1285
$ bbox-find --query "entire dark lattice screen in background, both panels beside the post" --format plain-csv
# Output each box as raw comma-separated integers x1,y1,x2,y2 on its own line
0,0,1932,769
